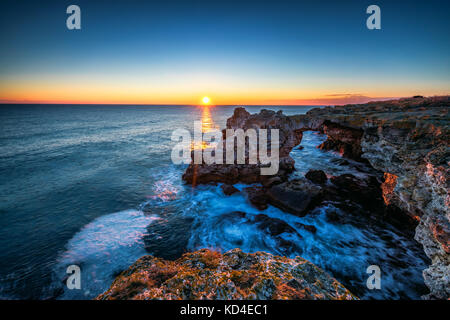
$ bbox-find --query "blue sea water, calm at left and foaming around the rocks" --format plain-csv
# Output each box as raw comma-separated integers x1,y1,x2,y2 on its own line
0,105,428,299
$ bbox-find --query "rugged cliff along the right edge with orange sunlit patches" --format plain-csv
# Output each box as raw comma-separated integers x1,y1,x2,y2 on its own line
291,96,450,299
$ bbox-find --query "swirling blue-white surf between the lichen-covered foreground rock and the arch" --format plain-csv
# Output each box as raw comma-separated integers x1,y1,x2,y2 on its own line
186,184,426,299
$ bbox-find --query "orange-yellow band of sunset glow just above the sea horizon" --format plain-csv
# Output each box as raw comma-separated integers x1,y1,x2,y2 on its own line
0,80,449,106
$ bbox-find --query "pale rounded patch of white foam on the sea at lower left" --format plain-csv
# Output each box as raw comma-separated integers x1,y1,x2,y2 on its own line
55,210,159,299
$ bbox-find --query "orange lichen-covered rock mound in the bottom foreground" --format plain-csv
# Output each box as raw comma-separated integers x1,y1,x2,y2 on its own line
97,249,357,300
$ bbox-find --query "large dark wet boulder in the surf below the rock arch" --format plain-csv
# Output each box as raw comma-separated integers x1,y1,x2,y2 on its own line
266,179,323,217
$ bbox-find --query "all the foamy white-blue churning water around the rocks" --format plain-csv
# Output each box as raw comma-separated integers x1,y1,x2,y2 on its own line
51,132,426,299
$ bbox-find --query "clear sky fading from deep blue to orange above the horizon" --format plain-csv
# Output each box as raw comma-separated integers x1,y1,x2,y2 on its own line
0,0,450,105
